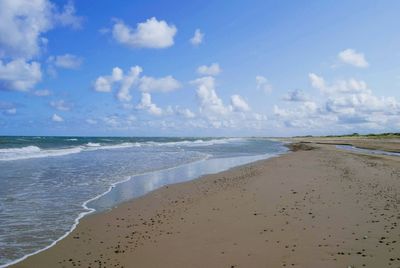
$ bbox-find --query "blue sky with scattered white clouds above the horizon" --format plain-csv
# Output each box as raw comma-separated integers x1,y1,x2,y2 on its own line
0,0,400,136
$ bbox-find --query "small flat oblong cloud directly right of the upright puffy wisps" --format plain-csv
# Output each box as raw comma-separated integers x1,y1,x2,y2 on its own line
139,75,181,92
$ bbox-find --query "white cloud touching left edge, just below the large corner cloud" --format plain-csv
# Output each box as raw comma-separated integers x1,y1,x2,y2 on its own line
0,59,42,91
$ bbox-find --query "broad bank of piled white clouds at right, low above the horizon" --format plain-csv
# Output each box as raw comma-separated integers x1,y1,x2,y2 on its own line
274,74,400,131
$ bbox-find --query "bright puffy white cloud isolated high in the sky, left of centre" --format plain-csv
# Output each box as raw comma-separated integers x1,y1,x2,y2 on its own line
112,17,177,48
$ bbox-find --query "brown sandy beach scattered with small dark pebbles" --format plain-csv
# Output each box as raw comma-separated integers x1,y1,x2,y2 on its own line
13,141,400,268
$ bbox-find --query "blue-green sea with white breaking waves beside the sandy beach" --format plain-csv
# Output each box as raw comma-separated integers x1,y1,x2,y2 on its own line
0,137,287,267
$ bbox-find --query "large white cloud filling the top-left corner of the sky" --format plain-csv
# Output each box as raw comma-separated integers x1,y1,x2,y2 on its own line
0,0,81,59
